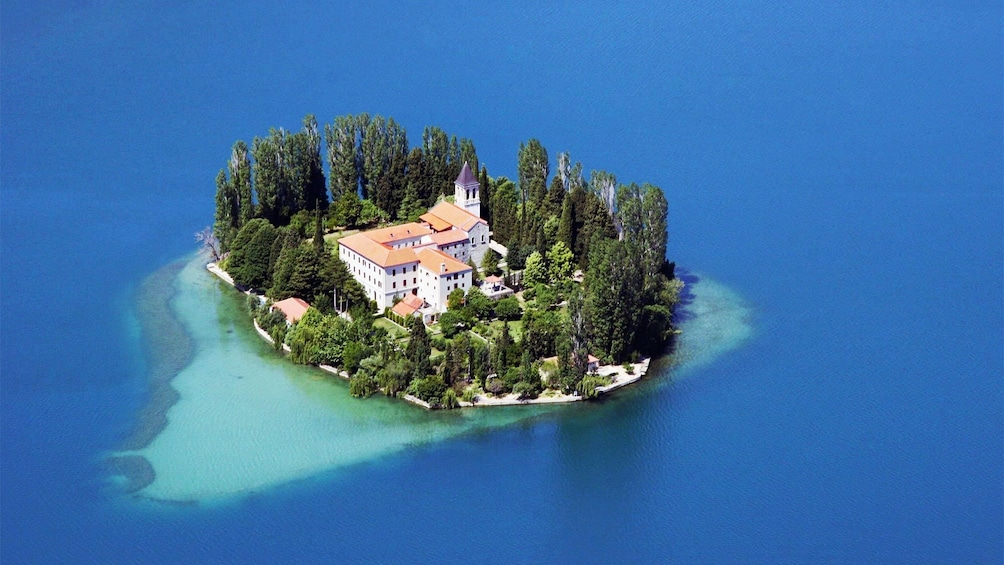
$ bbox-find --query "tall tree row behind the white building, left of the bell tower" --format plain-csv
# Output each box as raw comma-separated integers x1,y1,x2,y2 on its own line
214,113,477,253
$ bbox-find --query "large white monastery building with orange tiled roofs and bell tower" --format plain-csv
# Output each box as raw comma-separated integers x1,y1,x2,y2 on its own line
338,163,491,319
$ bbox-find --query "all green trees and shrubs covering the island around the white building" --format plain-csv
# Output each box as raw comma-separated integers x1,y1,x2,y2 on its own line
210,113,683,407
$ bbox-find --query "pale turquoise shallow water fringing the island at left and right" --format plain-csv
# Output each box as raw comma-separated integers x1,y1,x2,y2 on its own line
121,256,752,502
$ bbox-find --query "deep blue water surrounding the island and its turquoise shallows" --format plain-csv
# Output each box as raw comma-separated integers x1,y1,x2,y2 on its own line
0,1,1004,563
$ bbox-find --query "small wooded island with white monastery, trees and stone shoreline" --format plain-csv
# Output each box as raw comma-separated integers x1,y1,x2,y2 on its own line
205,113,684,408
